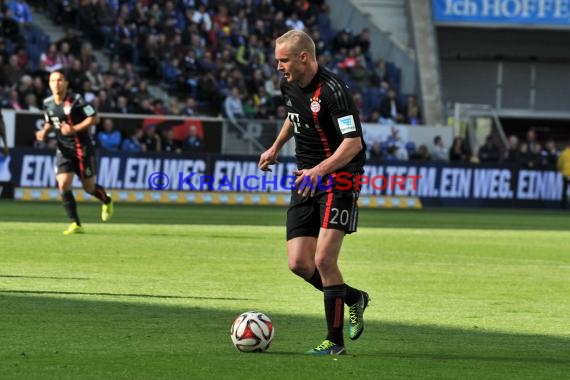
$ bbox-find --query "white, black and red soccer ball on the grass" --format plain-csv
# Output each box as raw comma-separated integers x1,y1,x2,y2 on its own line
230,311,275,352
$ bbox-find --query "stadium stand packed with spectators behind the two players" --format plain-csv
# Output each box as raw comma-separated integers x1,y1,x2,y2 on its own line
0,0,560,168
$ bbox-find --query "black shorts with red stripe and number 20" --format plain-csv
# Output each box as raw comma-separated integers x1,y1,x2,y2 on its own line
287,173,359,240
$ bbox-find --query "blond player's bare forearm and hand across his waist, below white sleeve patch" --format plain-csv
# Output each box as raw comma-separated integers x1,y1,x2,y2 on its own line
295,137,362,197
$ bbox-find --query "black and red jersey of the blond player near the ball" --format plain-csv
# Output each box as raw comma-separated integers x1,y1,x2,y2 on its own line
281,66,366,172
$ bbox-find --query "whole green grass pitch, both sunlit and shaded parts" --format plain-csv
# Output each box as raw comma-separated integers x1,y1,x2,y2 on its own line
0,202,570,380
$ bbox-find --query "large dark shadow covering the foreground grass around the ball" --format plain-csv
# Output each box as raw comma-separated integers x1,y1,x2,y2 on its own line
0,294,570,379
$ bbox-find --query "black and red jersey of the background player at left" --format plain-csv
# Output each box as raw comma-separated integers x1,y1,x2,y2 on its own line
44,91,97,157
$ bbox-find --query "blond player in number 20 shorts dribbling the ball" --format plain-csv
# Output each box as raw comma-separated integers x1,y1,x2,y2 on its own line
258,30,368,355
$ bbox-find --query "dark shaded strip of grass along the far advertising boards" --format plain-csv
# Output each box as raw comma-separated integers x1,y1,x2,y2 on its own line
0,201,570,231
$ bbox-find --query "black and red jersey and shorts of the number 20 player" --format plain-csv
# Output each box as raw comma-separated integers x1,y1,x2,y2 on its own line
281,66,366,240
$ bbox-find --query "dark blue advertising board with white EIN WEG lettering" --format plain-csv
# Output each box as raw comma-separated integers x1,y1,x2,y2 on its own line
4,149,562,208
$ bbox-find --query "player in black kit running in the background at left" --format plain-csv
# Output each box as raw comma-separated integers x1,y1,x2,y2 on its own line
36,71,113,235
